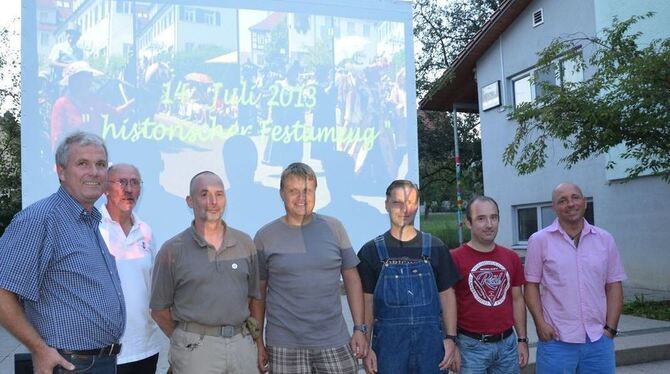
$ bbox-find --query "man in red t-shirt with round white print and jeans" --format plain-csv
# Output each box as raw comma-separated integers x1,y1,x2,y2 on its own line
451,196,528,373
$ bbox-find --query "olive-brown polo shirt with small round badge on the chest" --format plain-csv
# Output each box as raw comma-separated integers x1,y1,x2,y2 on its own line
149,225,260,326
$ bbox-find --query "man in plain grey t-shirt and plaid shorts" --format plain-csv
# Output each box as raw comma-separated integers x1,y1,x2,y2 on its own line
252,163,368,374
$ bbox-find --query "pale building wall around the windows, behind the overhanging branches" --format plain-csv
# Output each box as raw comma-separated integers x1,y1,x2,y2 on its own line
477,0,670,291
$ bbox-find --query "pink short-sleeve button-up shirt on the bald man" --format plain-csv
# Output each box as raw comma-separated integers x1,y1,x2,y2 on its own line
524,219,626,343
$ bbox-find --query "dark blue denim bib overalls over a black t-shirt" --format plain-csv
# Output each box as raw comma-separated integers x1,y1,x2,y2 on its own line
372,233,444,374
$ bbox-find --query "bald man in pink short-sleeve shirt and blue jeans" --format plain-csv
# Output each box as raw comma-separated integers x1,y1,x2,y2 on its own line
525,183,626,373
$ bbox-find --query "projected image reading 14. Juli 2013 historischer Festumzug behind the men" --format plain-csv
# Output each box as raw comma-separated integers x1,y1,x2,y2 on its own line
24,0,418,246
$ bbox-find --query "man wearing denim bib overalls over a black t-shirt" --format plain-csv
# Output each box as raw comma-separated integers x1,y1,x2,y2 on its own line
358,180,460,374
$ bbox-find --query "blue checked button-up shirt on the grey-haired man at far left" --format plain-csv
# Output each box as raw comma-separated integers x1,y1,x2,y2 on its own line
0,187,126,350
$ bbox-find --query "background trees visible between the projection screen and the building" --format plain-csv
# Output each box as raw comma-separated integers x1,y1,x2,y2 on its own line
413,0,501,206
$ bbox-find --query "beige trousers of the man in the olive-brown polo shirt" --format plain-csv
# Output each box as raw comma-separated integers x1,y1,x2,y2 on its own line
168,327,258,374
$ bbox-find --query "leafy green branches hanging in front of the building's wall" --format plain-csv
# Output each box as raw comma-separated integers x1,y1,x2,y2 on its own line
503,13,670,181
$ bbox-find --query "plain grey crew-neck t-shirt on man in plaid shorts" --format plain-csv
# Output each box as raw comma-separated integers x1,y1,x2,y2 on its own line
254,214,358,349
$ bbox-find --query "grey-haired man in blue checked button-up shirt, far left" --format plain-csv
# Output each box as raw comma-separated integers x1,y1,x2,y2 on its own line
0,132,125,373
